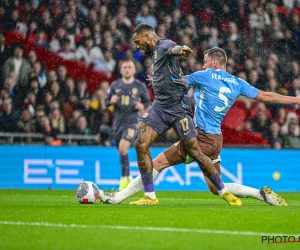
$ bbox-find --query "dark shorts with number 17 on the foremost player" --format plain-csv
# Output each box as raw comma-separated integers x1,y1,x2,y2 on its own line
141,103,197,140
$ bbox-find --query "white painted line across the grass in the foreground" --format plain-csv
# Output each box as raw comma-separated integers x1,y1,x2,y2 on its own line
0,221,300,237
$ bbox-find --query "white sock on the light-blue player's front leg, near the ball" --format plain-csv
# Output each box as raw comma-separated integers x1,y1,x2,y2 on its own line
115,169,159,203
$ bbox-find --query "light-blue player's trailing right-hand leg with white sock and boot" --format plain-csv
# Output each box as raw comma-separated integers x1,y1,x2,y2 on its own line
204,162,287,206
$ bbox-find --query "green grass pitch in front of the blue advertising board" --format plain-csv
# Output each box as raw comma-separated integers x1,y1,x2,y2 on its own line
0,190,300,250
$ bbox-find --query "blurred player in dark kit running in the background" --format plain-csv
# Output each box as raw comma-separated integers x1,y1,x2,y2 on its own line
105,60,150,190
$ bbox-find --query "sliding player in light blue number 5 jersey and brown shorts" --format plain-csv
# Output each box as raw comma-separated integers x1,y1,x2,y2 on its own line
99,48,300,206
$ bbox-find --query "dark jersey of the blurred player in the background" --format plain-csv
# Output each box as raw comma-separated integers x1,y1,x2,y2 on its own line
105,79,150,131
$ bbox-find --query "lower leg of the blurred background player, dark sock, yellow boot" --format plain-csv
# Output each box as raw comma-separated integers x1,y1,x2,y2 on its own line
118,139,132,190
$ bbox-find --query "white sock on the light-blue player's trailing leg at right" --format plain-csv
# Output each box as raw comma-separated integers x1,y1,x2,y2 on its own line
224,183,264,201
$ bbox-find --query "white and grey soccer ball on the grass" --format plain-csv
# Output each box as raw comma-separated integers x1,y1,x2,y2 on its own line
75,181,99,204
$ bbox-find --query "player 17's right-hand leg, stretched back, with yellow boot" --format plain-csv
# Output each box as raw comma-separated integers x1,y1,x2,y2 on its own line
181,137,242,206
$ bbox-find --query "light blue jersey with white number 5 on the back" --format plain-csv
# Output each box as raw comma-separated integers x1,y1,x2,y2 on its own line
186,68,259,134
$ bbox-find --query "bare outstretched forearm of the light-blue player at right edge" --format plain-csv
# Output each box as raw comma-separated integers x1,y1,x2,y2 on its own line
255,91,300,104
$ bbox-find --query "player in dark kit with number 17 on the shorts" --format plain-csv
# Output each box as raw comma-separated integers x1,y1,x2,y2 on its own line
130,23,242,206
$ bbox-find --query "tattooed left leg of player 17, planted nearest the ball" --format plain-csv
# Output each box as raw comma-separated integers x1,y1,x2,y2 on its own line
130,122,159,205
